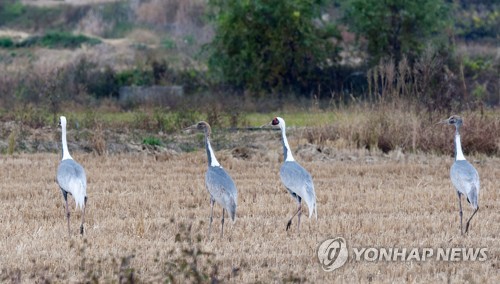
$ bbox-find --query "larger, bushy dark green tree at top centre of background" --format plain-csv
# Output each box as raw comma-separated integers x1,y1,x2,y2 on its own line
208,0,339,93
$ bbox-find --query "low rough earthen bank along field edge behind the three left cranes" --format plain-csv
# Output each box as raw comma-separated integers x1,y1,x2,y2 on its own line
0,121,428,168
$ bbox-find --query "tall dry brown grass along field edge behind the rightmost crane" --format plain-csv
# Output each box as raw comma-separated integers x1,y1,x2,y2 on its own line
304,103,500,155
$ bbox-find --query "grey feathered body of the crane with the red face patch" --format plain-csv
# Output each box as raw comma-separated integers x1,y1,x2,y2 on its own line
280,161,317,217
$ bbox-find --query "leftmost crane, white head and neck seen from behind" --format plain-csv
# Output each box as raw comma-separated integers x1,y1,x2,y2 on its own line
57,116,87,236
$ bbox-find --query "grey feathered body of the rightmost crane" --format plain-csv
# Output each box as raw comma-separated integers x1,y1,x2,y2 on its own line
450,160,480,209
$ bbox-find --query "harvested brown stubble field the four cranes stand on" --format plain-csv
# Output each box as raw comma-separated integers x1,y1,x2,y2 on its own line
0,138,500,283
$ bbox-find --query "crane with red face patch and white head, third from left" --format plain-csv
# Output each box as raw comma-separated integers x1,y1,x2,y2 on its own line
266,117,318,231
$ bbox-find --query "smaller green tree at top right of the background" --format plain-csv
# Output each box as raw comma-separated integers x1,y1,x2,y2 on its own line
343,0,449,63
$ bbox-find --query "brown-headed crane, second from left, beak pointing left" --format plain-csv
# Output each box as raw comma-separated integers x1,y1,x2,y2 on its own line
186,121,238,237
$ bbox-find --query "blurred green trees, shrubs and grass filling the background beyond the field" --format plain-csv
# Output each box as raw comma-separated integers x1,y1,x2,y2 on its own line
0,0,500,154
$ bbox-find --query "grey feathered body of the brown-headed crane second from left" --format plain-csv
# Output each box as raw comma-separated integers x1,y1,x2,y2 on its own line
205,165,238,221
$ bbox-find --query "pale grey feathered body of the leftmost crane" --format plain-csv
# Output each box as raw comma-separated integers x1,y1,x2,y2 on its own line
57,159,87,208
